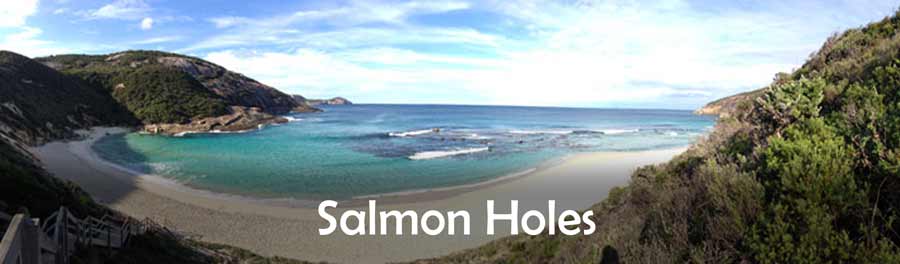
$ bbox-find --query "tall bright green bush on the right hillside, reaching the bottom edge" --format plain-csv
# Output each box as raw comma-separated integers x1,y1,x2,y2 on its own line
750,118,866,263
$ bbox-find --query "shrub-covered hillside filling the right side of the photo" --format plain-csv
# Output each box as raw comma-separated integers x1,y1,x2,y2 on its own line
419,8,900,263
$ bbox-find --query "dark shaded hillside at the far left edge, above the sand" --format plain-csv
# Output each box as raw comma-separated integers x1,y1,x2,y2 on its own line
0,51,138,145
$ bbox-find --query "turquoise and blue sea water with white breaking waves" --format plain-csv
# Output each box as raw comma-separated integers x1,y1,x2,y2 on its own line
93,105,714,199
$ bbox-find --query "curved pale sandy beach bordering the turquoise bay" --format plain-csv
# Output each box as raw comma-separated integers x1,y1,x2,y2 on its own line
32,128,684,263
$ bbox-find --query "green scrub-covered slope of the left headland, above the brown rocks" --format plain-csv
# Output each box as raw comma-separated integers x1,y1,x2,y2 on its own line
38,51,229,124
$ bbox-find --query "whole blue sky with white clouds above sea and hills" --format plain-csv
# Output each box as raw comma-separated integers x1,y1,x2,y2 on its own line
0,0,900,109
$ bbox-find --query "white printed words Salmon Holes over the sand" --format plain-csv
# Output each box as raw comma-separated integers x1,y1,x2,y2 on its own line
319,200,597,236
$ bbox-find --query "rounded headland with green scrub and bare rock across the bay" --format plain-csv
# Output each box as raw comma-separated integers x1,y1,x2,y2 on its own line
30,51,318,134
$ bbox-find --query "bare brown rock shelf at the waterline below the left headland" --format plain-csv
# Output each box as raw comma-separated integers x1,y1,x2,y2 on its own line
143,106,288,136
